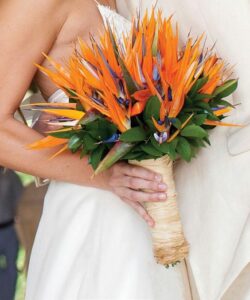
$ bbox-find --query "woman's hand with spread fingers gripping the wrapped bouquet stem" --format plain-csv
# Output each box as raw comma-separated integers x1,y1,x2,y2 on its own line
108,163,167,227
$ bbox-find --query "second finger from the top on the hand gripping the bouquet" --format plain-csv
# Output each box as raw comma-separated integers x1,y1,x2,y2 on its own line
115,176,167,192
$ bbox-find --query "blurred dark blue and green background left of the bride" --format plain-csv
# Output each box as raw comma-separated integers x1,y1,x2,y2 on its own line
0,87,47,300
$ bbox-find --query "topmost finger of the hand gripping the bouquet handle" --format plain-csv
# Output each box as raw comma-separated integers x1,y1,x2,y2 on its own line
115,163,162,182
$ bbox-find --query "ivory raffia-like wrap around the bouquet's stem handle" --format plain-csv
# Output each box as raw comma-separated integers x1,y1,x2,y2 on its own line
129,155,189,265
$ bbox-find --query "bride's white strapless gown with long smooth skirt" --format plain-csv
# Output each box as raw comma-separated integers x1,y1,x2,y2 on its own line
26,6,189,300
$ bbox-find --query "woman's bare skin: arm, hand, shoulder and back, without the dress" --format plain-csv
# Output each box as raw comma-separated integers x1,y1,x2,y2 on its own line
0,0,166,224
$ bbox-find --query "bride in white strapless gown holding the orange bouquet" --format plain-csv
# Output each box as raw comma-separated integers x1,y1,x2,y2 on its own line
0,0,189,300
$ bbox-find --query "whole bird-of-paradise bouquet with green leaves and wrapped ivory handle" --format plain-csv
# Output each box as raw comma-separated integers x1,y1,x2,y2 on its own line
24,9,240,265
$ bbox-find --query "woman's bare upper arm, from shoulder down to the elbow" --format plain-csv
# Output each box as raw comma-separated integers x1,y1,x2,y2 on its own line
0,0,70,114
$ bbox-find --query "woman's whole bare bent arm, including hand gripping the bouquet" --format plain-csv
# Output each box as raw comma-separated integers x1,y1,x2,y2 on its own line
0,0,166,226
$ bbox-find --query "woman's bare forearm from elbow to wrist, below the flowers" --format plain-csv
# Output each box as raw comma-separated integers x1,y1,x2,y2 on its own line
0,117,107,188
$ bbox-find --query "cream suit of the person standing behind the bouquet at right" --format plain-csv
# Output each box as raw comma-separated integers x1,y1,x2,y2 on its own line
117,0,250,300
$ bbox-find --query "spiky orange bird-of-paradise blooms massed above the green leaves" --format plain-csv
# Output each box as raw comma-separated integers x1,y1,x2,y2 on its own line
38,10,229,132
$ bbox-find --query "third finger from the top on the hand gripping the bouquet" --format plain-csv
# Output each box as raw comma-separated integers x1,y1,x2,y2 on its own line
114,187,167,202
